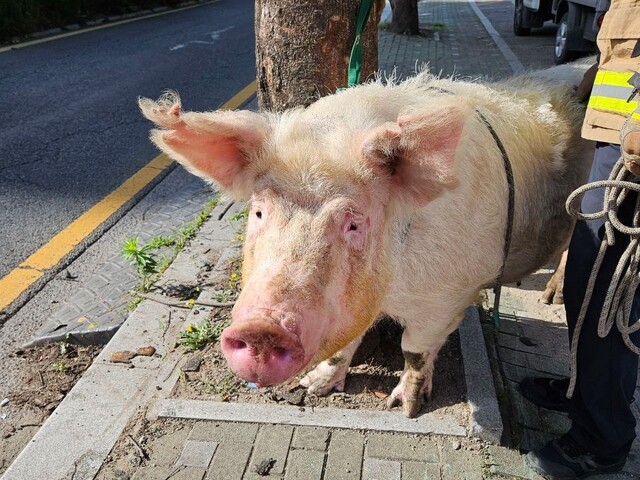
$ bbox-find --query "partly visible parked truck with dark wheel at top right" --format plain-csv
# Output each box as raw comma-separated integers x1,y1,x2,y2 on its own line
513,0,611,64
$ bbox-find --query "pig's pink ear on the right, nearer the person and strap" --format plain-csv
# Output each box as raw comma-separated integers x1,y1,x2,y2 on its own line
361,106,468,205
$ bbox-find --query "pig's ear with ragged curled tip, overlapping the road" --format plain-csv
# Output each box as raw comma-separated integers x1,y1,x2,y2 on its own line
138,94,270,197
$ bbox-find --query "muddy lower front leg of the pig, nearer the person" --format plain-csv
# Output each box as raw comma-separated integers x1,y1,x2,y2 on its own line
387,329,444,418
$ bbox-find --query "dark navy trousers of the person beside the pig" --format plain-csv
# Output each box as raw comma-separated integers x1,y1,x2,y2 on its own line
564,144,640,458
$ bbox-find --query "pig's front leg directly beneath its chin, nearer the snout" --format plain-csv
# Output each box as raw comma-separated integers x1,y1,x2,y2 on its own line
300,337,362,397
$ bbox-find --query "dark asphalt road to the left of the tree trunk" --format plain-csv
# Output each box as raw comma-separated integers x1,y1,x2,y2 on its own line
0,0,255,278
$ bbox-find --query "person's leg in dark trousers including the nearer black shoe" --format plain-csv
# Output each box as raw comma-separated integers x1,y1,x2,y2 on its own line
526,147,640,478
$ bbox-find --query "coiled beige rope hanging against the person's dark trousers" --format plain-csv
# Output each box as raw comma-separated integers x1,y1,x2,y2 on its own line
566,149,640,398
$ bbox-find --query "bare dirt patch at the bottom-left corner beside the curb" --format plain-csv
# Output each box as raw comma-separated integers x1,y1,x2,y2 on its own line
0,342,101,474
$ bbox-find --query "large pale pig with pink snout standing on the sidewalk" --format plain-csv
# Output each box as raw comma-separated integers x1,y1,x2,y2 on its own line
139,71,590,417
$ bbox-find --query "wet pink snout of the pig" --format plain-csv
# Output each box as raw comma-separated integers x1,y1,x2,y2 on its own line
221,320,304,387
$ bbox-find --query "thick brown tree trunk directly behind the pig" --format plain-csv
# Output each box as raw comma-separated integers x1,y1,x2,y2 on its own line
255,0,384,111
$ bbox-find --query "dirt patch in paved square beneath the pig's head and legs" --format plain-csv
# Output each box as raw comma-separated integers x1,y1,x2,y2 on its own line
173,309,468,425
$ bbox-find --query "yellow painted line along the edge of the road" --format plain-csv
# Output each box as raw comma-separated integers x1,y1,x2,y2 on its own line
0,80,256,311
